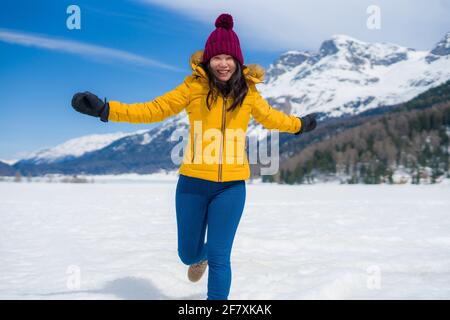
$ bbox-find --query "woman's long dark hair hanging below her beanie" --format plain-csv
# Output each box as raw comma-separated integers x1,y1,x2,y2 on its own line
200,57,248,111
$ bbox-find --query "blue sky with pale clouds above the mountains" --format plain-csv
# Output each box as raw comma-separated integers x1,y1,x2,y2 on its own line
0,0,450,159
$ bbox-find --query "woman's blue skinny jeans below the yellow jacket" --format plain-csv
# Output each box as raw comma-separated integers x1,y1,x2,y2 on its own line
176,175,246,300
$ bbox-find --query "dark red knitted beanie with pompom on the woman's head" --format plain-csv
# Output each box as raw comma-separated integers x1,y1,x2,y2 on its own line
203,13,244,64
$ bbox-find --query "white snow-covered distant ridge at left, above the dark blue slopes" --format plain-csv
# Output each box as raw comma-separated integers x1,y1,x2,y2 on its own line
21,130,148,164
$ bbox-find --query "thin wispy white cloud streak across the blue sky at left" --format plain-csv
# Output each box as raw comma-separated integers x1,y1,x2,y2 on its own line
0,29,185,72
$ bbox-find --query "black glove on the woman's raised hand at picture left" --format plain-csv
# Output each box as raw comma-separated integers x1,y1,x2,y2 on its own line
72,91,109,122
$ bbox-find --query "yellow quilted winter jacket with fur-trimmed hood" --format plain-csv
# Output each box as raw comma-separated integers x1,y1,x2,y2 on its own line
108,51,301,182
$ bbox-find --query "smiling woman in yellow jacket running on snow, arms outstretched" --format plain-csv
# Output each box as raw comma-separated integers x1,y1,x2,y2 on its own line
72,14,316,300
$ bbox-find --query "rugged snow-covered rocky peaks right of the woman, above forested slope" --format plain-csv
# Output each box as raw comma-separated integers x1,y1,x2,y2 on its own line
258,33,450,121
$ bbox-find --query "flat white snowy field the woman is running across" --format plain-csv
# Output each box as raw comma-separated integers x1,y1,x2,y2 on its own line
0,179,450,299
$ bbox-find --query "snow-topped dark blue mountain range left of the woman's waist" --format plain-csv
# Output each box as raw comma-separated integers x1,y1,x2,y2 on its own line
13,114,188,175
